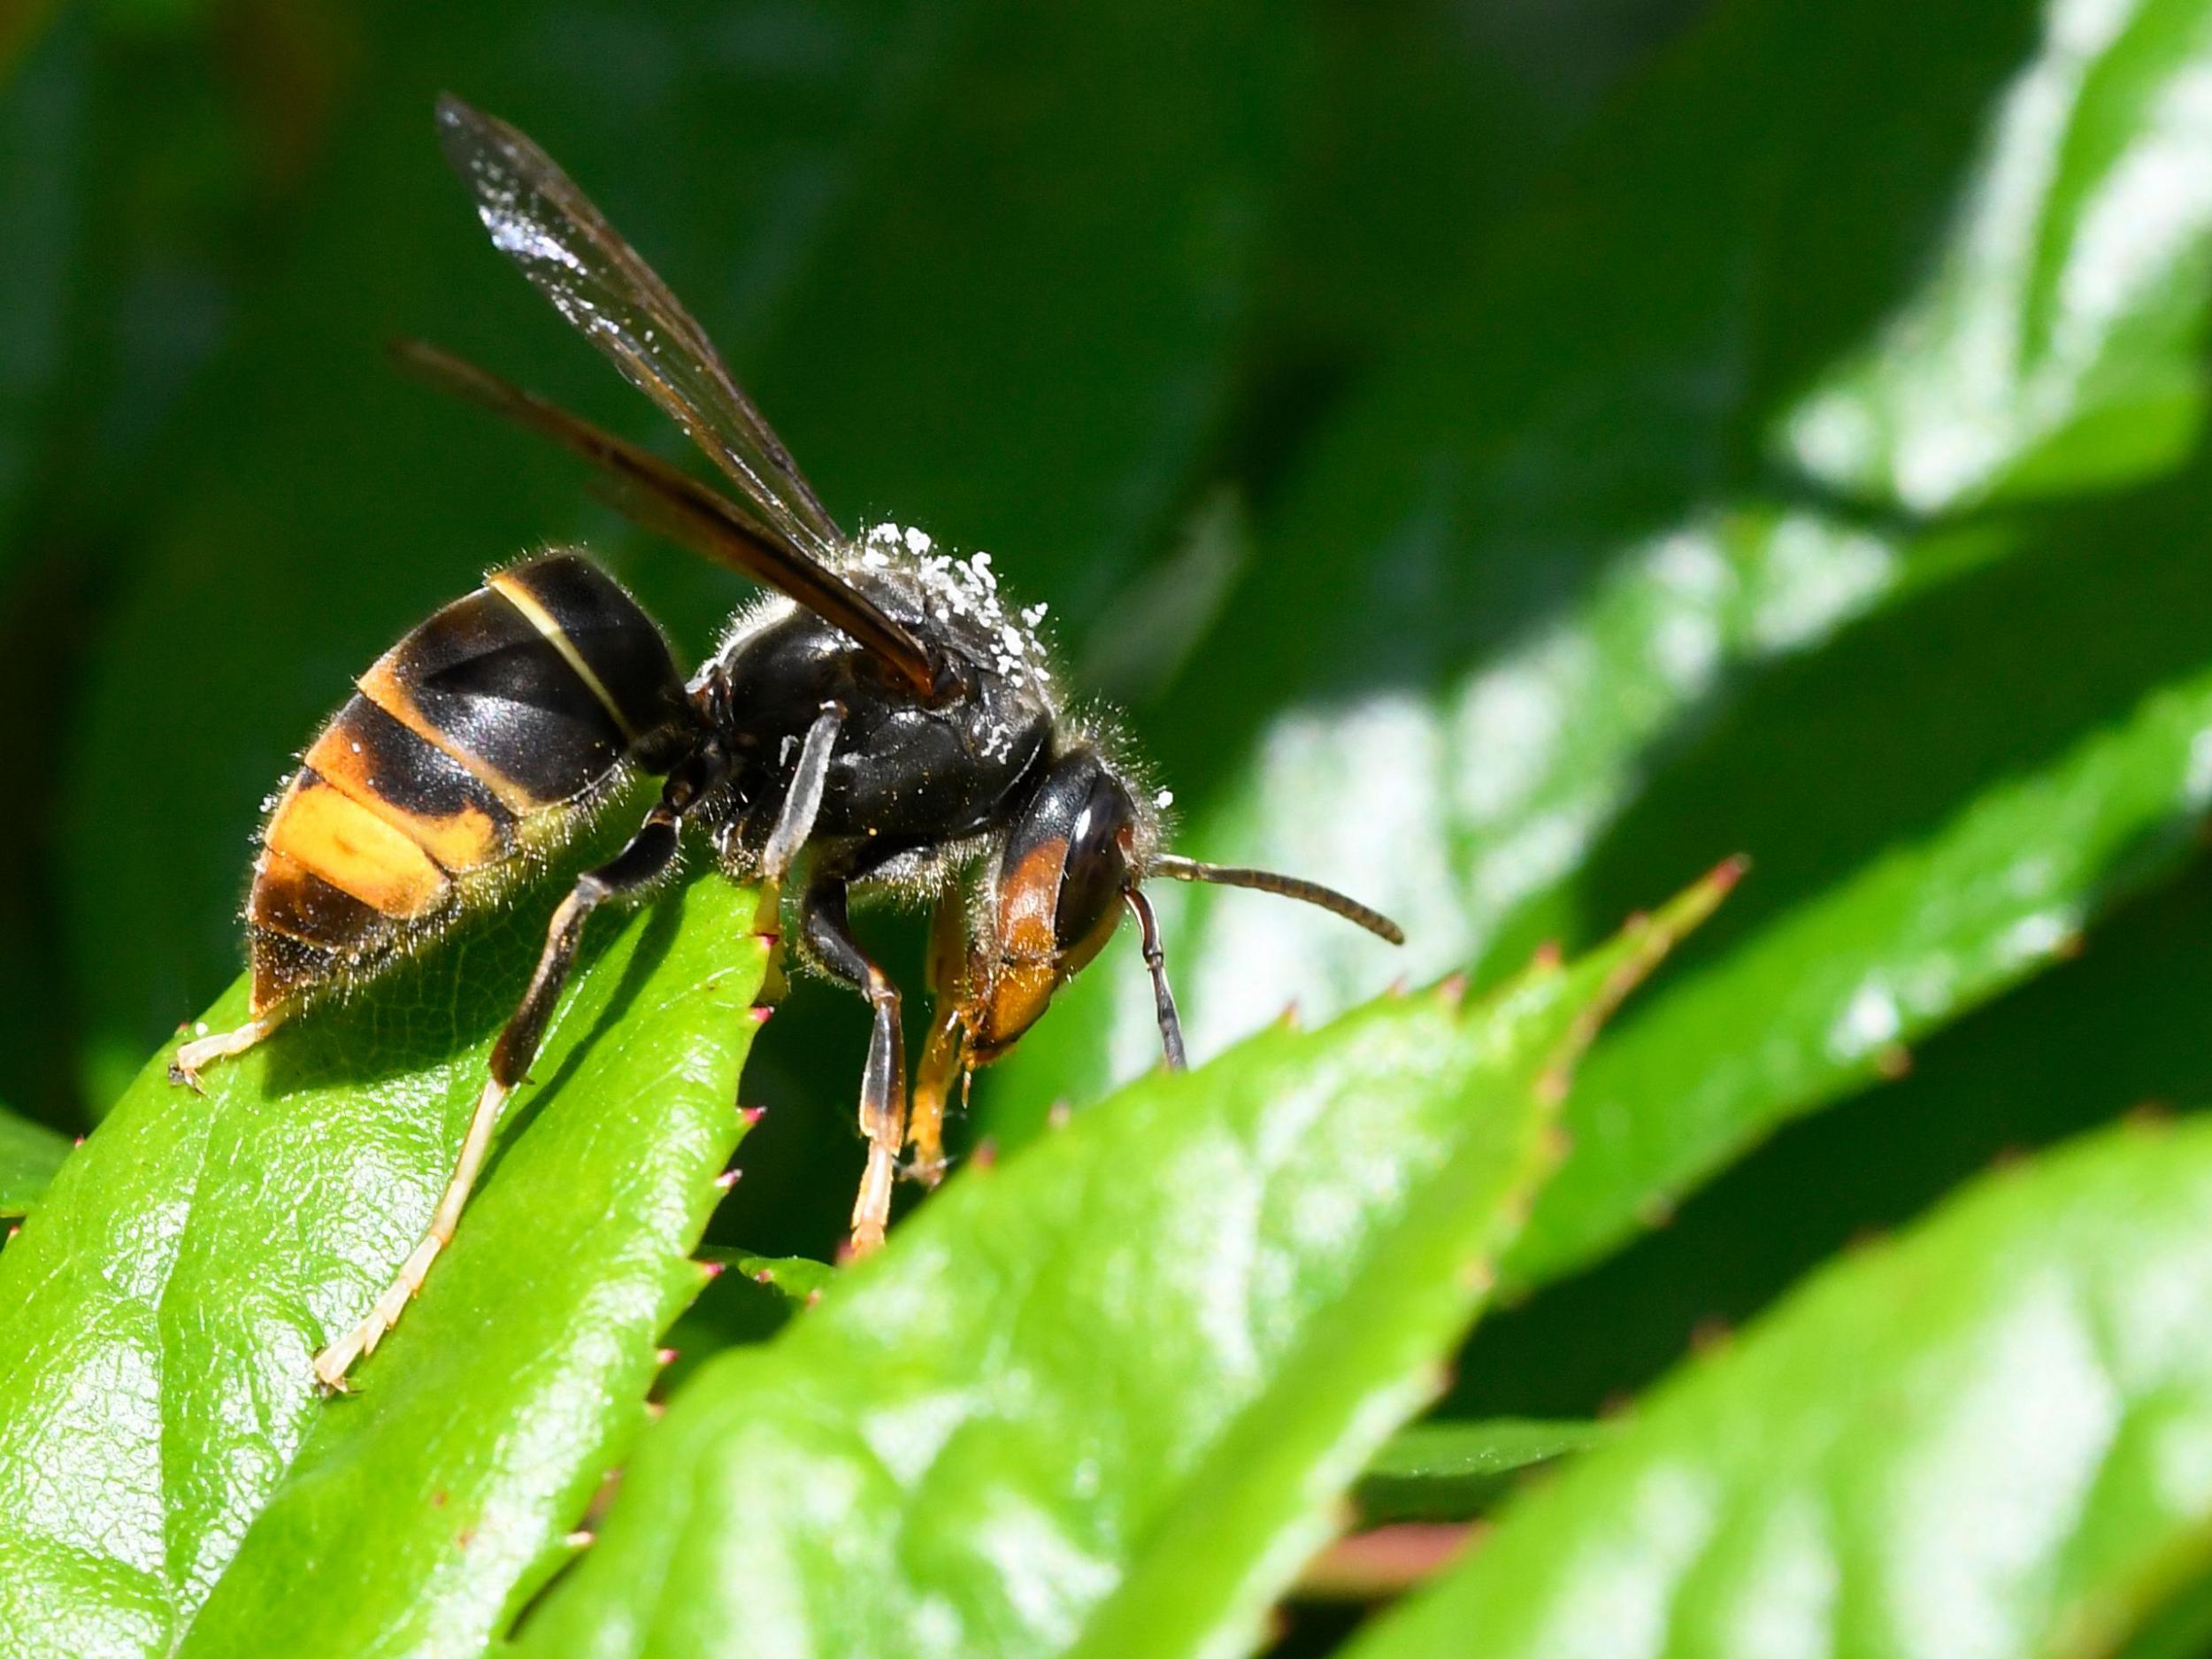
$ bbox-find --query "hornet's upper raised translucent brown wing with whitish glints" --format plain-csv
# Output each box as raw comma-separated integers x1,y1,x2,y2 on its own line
438,96,845,560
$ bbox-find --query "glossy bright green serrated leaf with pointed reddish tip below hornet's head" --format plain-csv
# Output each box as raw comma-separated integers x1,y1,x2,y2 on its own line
522,880,1724,1659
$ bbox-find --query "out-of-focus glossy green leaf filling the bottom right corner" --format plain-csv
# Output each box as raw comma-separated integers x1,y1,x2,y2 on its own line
1349,1119,2212,1659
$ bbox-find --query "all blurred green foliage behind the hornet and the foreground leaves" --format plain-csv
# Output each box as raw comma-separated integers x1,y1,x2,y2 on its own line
0,0,2212,1653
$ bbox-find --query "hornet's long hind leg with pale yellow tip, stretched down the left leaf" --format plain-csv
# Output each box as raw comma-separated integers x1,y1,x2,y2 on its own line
314,772,702,1389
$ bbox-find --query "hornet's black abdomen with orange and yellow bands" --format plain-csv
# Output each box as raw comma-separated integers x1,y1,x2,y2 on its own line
246,553,684,1018
